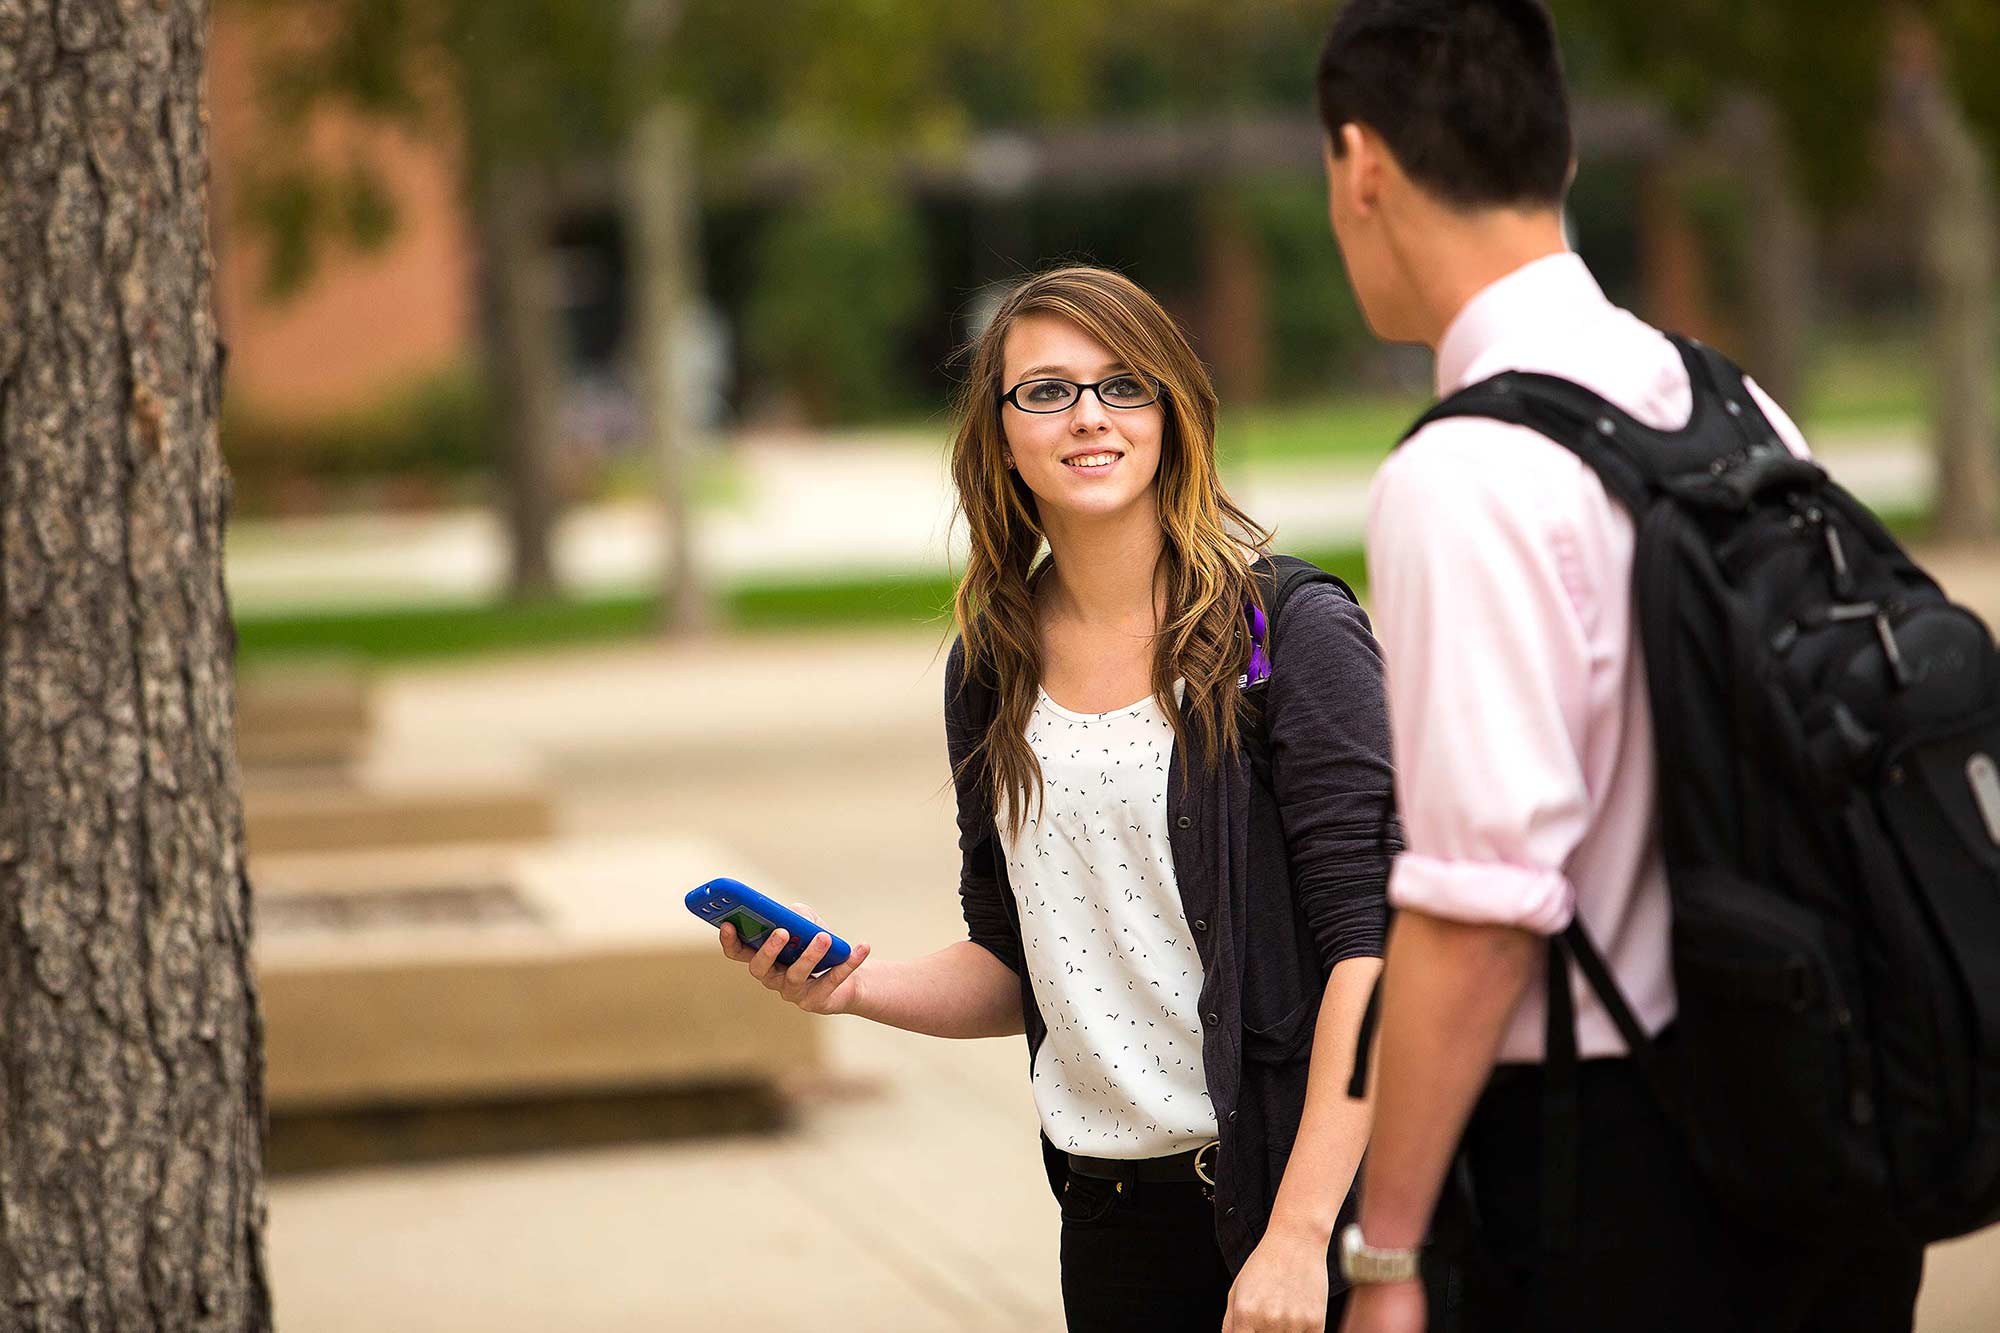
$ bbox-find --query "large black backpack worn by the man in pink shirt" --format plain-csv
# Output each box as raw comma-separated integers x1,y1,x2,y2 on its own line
1404,338,2000,1241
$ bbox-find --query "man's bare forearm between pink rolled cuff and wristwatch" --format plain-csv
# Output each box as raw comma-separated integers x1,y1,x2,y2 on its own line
1362,911,1542,1249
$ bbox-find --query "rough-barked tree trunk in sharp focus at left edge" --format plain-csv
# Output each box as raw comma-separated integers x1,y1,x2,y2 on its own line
0,0,270,1329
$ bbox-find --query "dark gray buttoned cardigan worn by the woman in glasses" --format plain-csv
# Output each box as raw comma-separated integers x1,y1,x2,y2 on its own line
944,564,1400,1269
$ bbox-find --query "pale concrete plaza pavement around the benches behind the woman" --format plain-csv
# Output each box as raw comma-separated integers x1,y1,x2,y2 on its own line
270,596,2000,1333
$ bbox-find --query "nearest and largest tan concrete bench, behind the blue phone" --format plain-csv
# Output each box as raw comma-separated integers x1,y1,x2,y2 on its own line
252,839,820,1113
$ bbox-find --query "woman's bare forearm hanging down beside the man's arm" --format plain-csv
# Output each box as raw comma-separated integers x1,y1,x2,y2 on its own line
1270,959,1382,1239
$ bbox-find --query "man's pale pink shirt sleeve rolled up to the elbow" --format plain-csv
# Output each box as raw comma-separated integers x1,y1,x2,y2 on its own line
1368,420,1594,935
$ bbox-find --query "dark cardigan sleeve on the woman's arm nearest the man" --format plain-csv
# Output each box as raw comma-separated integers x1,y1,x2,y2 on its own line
1266,582,1400,967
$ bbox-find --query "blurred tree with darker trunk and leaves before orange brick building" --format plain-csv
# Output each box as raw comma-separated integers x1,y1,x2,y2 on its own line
224,0,630,596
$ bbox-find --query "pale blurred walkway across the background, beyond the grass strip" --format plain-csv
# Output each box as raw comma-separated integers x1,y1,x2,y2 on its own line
228,432,1930,612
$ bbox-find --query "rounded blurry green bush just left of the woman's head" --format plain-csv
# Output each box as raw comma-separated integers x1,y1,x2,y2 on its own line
744,190,926,420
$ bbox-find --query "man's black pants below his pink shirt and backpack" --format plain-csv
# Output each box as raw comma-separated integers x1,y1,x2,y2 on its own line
1424,1059,1924,1333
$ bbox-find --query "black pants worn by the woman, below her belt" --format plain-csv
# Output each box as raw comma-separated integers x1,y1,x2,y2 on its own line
1062,1173,1346,1333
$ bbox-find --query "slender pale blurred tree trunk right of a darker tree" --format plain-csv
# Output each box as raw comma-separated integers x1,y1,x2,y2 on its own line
626,102,714,634
